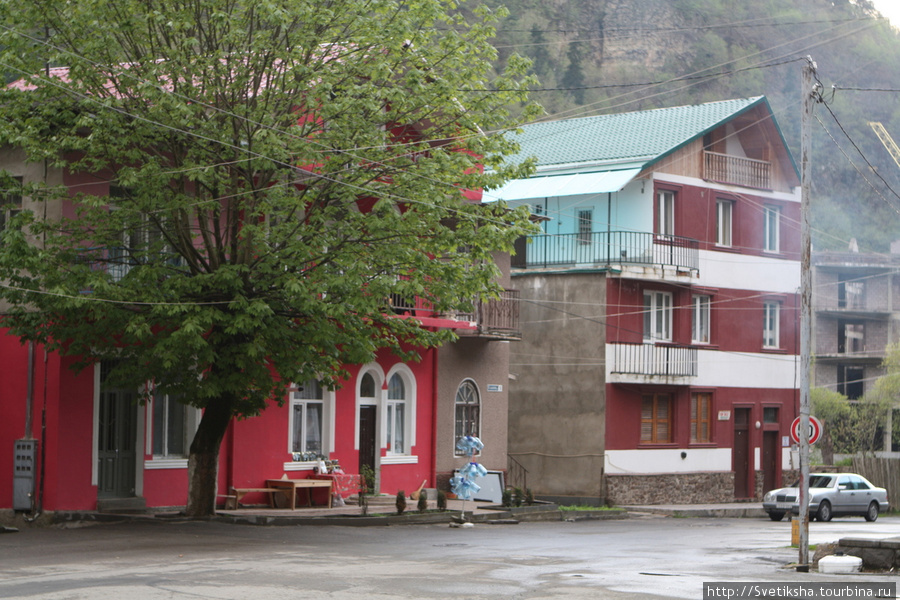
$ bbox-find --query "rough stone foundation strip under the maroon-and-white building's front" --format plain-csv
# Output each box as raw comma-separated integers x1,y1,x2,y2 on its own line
606,471,734,506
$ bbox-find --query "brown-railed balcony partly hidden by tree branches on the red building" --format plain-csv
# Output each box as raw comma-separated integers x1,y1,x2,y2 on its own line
390,289,522,340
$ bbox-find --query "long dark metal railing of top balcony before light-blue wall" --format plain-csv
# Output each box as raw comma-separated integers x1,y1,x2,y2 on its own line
512,231,700,271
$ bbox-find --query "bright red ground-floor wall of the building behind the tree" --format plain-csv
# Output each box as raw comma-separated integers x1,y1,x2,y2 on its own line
0,328,437,511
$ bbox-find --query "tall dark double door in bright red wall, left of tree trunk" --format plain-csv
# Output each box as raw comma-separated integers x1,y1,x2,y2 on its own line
97,382,137,498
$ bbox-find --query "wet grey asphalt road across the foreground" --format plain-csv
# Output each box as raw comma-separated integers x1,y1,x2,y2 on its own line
0,517,900,600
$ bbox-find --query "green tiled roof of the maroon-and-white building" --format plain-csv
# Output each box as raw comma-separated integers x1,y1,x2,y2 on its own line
509,96,768,170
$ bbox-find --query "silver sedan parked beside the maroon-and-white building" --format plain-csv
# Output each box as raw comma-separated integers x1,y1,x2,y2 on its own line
763,473,889,521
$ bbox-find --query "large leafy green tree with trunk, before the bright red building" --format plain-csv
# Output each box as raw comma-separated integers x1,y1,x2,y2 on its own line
0,0,535,516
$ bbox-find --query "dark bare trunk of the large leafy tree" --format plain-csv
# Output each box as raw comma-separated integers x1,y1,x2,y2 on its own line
185,397,234,518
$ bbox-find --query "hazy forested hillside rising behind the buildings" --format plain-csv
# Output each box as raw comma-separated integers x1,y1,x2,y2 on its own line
468,0,900,252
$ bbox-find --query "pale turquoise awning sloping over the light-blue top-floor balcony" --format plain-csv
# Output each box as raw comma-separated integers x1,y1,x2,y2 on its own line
484,169,641,202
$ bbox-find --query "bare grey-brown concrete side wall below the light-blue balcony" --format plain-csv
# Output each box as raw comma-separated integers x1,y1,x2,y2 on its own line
509,272,606,497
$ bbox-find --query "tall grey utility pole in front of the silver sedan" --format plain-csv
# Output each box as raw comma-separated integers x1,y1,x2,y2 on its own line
797,56,821,572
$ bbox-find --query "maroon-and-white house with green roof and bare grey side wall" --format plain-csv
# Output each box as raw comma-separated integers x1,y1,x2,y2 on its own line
495,97,800,504
